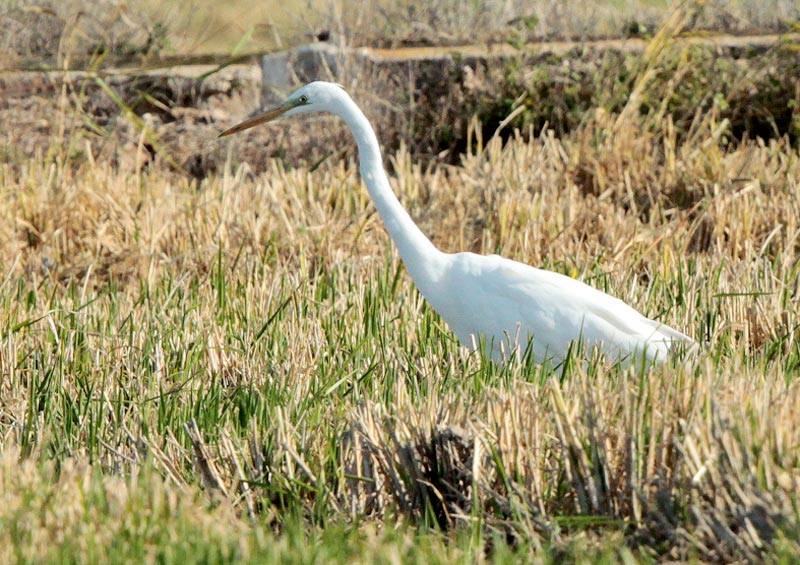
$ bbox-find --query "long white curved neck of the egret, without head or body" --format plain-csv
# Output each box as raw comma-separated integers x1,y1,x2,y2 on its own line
340,99,441,284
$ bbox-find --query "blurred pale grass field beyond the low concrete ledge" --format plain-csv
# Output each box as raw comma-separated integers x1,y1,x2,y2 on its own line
0,0,800,69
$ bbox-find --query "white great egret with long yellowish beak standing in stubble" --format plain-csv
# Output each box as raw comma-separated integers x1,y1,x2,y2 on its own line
220,82,693,364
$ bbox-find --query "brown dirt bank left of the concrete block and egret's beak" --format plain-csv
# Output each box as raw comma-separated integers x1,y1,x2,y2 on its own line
0,64,261,177
